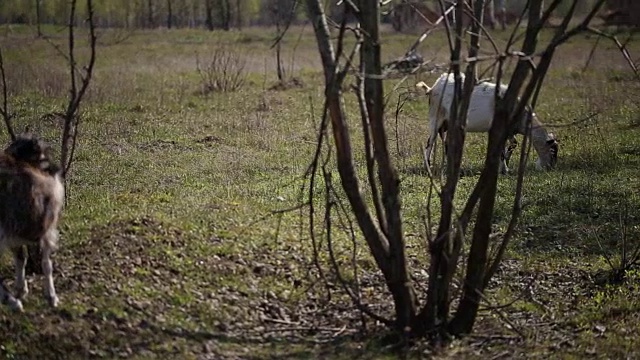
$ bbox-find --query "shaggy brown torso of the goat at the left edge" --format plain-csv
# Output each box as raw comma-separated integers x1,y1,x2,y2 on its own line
0,156,64,242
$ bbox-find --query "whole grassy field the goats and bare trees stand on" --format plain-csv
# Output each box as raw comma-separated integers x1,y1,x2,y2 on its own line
0,26,640,359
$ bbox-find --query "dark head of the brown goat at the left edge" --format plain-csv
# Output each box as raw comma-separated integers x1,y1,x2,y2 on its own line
4,133,59,174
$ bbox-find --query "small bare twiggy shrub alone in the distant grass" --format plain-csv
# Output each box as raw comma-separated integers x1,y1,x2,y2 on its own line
196,46,247,95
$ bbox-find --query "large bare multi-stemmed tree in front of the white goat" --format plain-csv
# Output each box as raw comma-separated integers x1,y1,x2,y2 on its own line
306,0,616,340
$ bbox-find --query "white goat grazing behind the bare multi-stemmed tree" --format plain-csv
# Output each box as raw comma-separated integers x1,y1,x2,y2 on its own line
416,73,558,173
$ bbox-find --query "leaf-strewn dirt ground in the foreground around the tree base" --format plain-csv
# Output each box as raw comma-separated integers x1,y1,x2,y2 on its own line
0,218,634,359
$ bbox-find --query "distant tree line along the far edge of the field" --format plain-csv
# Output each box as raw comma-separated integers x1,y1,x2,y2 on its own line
0,0,620,31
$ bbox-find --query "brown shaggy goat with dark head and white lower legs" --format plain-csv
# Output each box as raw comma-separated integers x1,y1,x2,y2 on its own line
0,135,64,311
